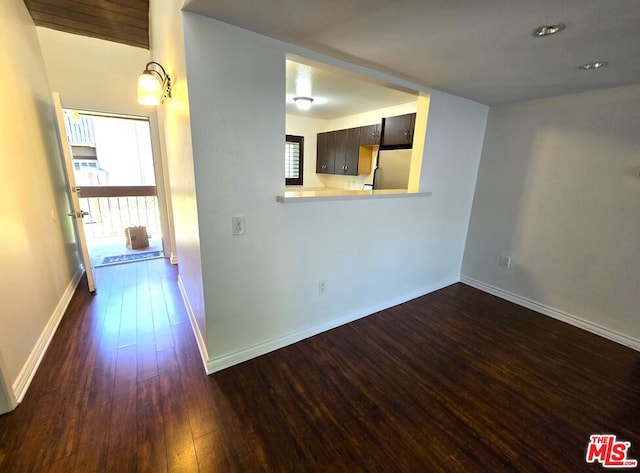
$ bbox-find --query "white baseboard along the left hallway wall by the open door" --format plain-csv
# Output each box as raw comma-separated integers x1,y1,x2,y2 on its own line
12,266,84,403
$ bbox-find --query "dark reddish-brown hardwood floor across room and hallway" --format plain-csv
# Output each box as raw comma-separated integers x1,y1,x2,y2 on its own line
0,260,640,473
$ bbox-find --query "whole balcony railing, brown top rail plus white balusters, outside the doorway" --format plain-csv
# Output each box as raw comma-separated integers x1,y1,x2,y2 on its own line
80,186,161,239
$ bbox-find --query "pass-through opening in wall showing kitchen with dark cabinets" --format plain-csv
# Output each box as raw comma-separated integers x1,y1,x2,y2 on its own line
285,54,430,195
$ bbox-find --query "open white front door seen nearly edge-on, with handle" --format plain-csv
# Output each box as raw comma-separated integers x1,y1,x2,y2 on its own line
52,92,96,292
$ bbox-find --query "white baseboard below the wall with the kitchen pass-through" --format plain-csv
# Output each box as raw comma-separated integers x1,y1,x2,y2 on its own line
207,278,459,374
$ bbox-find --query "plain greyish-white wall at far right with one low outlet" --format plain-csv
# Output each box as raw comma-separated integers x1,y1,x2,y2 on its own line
463,86,640,346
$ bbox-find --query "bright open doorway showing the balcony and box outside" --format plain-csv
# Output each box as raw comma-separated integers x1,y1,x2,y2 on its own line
64,109,164,267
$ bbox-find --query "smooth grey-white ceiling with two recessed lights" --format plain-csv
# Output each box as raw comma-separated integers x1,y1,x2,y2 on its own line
184,0,640,106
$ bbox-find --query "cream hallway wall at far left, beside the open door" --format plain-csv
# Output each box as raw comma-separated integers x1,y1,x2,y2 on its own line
0,0,80,398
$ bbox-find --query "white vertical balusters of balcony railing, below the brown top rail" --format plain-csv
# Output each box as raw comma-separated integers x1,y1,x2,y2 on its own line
80,196,161,239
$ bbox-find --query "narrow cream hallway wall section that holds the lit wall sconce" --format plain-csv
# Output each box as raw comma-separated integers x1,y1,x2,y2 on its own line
150,0,205,342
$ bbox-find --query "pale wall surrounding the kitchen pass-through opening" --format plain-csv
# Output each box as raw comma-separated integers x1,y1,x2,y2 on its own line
184,13,487,370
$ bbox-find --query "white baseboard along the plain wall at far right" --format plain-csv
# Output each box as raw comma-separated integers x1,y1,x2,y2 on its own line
460,276,640,351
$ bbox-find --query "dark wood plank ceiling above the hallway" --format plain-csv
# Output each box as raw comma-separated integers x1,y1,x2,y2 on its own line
24,0,149,49
